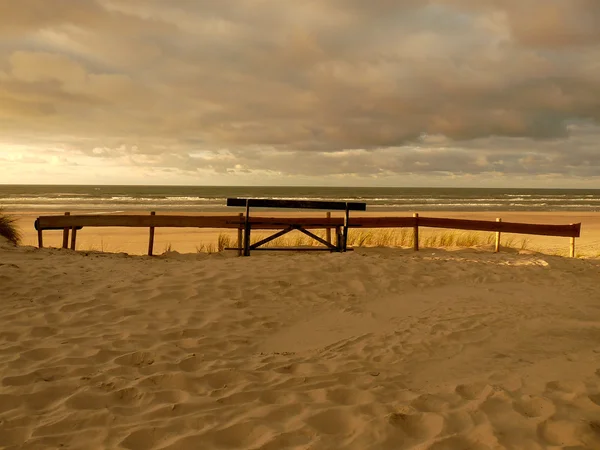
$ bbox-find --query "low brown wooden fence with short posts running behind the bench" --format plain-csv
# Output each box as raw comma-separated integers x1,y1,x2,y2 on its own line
35,212,581,257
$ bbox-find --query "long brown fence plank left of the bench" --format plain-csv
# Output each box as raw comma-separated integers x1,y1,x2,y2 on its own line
38,214,239,230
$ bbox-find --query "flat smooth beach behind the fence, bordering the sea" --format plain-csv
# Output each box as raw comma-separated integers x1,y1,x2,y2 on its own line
7,208,600,257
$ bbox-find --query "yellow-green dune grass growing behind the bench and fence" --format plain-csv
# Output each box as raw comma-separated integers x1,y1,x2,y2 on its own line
196,228,528,253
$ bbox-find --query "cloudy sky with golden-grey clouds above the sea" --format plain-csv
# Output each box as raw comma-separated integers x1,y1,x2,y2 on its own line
0,0,600,188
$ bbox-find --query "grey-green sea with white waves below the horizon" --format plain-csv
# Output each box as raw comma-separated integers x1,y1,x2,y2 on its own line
0,185,600,213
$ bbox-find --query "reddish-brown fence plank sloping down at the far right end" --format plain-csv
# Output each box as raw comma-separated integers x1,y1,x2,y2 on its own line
419,217,581,237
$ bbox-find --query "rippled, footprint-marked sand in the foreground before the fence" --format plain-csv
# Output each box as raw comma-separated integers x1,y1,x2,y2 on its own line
0,244,600,450
